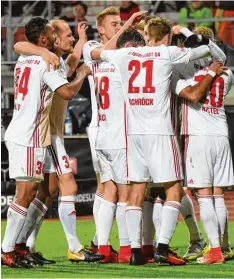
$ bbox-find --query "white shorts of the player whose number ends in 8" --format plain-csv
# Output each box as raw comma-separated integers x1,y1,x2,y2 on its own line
96,148,128,184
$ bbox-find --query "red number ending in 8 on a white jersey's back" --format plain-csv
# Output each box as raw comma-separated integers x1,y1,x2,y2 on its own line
94,76,110,110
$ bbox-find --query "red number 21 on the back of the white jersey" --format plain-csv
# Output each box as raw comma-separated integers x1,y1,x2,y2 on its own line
128,60,155,93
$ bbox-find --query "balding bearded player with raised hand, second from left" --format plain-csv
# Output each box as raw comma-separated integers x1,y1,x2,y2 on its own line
11,20,101,263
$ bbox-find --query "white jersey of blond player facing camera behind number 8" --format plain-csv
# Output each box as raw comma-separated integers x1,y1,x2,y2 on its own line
83,41,102,127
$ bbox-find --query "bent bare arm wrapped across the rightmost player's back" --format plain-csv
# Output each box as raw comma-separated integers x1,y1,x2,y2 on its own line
179,62,225,104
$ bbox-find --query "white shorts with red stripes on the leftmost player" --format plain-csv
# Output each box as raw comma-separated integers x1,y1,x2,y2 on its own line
6,141,46,181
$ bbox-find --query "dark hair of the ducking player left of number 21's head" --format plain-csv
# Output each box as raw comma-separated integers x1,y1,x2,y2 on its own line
116,27,145,48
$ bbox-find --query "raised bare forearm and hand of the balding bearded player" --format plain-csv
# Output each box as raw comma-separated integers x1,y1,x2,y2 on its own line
66,21,88,77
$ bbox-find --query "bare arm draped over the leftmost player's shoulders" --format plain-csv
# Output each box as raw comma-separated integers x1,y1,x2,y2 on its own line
14,42,60,71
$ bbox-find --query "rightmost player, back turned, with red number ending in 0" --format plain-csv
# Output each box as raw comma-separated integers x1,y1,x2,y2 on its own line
173,27,234,264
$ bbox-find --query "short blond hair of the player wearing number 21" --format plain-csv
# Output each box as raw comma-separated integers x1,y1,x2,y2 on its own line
147,17,172,42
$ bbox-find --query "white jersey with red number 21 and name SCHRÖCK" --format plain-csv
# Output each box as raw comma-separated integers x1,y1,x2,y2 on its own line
101,45,193,135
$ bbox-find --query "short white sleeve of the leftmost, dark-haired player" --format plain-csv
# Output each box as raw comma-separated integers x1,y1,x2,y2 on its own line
42,66,68,91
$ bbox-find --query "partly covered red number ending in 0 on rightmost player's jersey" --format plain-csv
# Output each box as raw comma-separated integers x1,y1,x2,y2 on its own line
194,75,224,108
